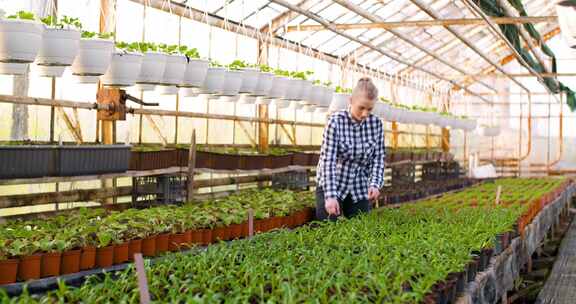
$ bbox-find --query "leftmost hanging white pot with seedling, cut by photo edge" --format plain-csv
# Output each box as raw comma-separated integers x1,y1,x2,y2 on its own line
0,11,44,75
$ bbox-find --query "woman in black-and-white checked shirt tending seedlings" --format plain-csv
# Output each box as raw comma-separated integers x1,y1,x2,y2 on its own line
316,78,384,220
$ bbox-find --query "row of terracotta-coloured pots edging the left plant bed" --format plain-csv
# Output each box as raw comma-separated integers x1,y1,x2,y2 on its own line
0,208,314,285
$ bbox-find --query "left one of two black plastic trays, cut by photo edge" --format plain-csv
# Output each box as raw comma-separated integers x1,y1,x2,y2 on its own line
0,145,57,179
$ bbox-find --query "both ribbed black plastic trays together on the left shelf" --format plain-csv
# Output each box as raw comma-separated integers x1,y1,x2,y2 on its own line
0,145,130,179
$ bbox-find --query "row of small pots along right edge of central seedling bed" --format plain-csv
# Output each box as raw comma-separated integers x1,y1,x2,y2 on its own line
420,181,570,304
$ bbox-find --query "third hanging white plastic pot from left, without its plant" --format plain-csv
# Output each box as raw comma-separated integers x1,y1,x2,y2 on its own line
72,38,114,76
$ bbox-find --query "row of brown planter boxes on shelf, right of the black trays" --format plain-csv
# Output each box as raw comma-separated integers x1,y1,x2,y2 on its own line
130,149,320,170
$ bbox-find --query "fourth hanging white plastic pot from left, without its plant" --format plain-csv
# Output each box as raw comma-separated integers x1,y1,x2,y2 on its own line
100,52,144,87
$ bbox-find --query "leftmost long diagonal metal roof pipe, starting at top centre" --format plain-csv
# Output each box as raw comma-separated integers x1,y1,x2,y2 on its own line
271,0,492,103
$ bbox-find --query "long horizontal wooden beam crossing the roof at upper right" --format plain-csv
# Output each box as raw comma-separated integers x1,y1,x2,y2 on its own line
287,16,558,32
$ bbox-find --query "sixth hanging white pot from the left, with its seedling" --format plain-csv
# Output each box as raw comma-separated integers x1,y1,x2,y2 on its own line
156,44,188,95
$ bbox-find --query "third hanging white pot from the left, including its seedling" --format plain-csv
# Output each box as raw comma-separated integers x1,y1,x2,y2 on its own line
71,31,114,83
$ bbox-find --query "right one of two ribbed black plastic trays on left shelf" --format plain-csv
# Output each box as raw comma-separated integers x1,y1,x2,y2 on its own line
56,145,131,176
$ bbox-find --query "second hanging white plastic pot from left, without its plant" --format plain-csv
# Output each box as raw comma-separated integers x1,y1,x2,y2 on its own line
35,27,80,66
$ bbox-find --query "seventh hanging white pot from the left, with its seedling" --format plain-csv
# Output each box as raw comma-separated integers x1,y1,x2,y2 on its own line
179,46,210,96
